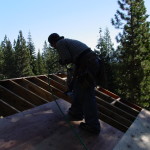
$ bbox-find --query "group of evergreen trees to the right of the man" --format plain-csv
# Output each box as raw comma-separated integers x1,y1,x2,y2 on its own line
97,0,150,109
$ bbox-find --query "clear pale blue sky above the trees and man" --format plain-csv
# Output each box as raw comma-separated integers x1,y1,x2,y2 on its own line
0,0,150,51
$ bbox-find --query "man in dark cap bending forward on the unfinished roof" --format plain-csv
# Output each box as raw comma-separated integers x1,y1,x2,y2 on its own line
48,33,104,134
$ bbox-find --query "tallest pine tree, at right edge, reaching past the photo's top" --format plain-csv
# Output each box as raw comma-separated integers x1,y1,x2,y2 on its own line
112,0,150,107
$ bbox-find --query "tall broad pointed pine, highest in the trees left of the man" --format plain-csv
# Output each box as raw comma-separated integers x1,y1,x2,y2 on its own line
15,31,33,77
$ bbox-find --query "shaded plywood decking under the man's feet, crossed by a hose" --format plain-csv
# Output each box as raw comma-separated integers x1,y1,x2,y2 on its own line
0,100,124,150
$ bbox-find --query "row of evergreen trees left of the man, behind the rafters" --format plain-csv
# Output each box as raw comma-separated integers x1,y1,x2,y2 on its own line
0,31,60,79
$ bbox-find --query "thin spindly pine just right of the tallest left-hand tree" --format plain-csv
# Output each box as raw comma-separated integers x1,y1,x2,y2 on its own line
27,32,37,74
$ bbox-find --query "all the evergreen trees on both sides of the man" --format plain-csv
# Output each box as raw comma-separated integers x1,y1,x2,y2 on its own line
0,0,150,109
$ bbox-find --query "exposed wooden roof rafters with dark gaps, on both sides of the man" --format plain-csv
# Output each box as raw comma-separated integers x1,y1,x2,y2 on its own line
0,74,141,132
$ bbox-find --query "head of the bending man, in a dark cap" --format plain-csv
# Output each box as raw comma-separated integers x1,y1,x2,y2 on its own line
48,33,64,48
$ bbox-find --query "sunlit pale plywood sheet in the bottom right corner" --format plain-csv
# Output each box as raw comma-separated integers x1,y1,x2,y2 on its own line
114,109,150,150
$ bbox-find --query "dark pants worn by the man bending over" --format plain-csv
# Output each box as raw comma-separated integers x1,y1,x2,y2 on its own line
70,55,100,130
